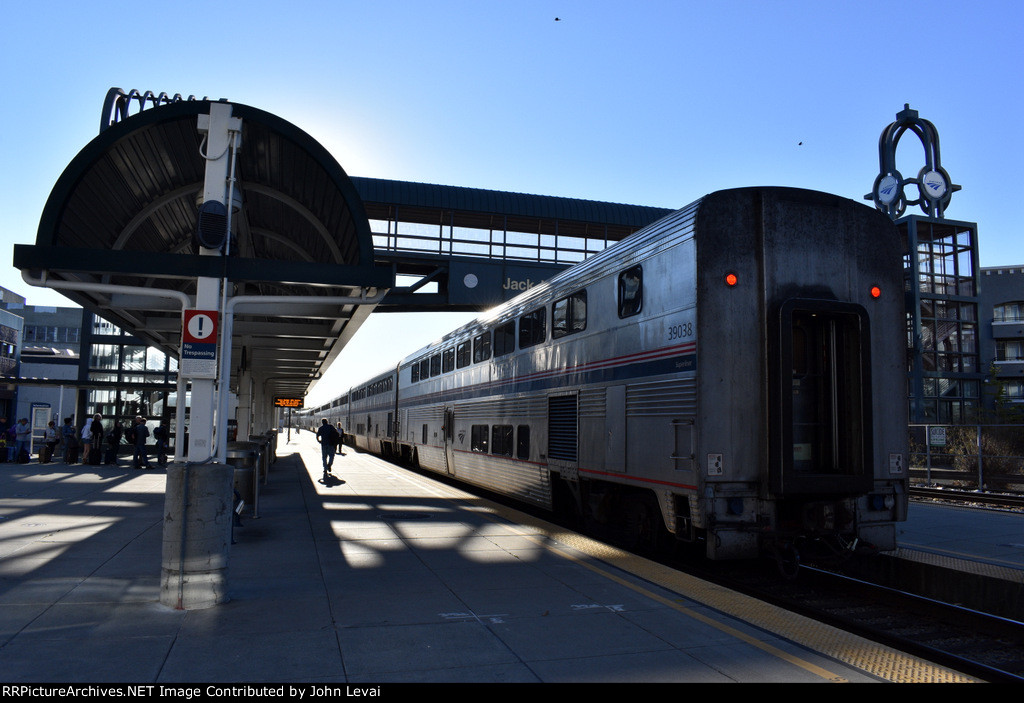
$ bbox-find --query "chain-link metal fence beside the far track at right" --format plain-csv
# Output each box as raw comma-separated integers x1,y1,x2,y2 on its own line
909,425,1024,492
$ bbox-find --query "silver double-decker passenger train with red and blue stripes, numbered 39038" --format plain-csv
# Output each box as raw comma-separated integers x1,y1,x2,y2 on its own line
314,187,907,559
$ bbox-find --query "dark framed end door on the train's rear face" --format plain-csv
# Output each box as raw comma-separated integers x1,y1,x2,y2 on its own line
771,300,873,495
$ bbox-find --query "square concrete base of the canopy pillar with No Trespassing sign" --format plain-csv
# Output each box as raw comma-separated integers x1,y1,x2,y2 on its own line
160,464,234,610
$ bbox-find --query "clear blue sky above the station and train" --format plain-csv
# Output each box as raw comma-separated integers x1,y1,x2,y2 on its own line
0,0,1024,401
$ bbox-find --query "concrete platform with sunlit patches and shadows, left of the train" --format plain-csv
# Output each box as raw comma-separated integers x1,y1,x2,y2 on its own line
0,431,971,693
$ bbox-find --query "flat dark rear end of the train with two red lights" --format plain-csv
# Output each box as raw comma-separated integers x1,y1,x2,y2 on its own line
690,188,907,563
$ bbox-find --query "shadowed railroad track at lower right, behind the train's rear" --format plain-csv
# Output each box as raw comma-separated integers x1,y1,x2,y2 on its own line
680,564,1024,683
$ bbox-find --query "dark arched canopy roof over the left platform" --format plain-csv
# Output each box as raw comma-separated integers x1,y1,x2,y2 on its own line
14,100,394,396
